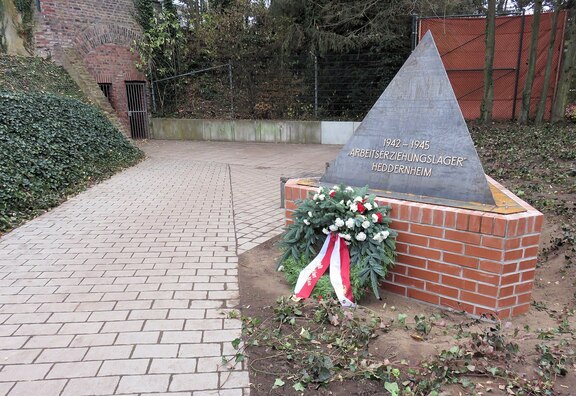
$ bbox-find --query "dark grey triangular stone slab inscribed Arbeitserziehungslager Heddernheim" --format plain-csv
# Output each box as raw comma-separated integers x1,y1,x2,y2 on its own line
320,32,494,205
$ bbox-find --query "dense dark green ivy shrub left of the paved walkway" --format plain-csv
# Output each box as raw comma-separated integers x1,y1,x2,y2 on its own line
0,91,143,231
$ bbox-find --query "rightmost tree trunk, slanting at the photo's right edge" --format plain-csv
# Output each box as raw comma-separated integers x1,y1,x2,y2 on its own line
552,4,576,122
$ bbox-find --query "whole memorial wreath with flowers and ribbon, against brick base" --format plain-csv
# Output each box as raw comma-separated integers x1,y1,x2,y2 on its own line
278,185,397,306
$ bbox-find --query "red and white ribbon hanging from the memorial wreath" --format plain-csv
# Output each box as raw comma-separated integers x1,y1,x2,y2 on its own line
294,232,356,307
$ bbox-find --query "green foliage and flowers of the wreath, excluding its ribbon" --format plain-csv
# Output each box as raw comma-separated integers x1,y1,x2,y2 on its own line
278,185,397,301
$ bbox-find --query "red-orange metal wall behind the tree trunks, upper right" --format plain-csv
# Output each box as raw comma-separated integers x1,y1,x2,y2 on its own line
418,13,566,120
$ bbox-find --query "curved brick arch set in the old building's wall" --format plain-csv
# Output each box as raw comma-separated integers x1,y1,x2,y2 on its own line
74,24,141,55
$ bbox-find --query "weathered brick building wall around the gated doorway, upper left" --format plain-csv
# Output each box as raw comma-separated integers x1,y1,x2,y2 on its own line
34,0,146,128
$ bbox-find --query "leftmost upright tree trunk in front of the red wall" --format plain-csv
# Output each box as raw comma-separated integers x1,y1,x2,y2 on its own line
480,0,496,124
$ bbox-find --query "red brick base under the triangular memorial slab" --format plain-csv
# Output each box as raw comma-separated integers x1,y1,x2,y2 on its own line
284,180,544,319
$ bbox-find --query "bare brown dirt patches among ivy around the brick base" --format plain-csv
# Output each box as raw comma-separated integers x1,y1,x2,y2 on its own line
239,227,576,395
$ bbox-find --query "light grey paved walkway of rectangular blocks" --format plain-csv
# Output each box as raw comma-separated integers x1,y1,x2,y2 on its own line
0,141,338,396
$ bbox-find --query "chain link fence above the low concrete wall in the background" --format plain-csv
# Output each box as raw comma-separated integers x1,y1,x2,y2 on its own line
152,49,409,120
